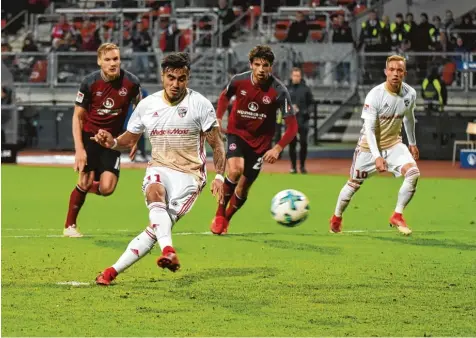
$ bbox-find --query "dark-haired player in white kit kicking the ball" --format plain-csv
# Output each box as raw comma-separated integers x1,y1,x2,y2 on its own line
92,53,225,285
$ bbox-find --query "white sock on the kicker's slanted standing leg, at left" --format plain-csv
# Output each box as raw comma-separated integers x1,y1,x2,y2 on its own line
112,229,157,273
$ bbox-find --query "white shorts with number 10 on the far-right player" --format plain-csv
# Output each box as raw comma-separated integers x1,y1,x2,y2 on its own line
350,143,415,181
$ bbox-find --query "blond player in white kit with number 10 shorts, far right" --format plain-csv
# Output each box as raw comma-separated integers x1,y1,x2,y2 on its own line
330,55,420,235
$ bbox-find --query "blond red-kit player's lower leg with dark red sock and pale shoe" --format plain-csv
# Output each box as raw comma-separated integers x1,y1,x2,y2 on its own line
63,172,94,237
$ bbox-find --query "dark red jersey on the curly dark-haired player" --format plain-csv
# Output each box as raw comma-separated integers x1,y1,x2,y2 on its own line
222,71,294,153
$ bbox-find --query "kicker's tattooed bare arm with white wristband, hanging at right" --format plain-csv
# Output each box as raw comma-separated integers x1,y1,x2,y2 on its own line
205,127,226,203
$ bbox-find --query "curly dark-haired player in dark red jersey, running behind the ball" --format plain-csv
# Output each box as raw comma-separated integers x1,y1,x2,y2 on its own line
211,45,298,235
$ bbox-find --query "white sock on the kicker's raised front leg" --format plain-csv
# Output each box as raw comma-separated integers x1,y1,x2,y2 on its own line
147,202,172,250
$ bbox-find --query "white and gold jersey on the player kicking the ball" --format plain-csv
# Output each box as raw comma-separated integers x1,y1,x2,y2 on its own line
127,89,218,182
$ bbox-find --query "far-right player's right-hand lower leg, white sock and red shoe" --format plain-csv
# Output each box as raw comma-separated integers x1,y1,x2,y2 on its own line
390,163,420,235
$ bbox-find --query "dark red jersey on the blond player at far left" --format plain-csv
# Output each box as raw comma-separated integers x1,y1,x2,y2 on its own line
75,69,140,136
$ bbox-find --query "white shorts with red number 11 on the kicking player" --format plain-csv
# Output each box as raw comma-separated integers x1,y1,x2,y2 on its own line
142,167,205,223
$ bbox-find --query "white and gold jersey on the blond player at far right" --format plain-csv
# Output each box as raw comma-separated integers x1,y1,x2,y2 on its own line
359,82,417,151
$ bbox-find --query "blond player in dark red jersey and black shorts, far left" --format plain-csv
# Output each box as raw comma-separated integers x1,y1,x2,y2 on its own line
63,43,141,237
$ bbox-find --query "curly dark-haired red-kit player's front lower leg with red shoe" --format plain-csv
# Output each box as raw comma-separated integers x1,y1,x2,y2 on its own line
210,157,245,235
